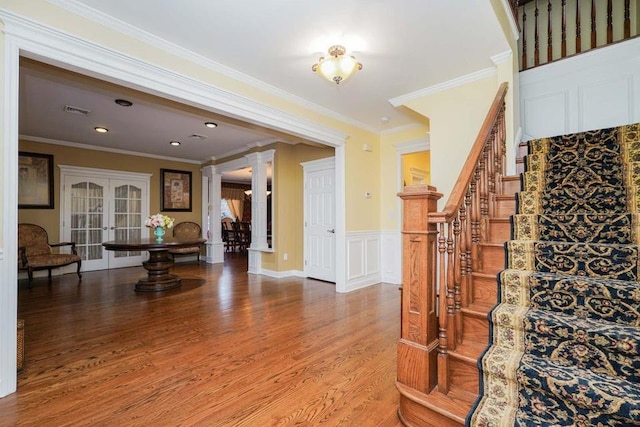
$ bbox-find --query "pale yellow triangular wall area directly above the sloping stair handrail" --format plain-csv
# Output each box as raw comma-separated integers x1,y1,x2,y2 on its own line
406,75,499,208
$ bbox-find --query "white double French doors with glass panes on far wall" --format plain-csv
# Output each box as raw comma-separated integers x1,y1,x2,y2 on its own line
61,166,149,271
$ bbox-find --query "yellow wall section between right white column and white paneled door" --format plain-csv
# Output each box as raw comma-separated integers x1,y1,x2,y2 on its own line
262,143,334,271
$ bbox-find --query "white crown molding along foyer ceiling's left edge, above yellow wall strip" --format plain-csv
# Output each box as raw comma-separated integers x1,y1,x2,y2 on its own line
46,0,377,133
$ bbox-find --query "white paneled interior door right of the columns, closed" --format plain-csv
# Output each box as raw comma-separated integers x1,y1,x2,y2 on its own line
303,158,336,282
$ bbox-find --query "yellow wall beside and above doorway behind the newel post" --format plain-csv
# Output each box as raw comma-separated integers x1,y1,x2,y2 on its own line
379,125,429,230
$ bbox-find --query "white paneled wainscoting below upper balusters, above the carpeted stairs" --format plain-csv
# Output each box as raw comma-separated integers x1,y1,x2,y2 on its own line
520,39,640,141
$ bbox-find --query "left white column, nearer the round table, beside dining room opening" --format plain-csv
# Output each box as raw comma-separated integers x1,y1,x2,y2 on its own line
201,166,224,264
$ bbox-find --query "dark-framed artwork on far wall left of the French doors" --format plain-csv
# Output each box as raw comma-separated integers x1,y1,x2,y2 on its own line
18,151,53,209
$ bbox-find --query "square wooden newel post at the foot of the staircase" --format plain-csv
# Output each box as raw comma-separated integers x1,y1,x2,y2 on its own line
397,186,442,394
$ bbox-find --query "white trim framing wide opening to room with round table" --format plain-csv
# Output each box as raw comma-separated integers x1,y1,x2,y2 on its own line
0,10,349,397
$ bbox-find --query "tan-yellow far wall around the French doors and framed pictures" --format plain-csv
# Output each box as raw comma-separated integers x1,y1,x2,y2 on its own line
18,140,202,242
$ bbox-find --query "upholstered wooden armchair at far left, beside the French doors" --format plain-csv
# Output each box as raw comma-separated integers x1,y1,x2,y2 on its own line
18,224,82,288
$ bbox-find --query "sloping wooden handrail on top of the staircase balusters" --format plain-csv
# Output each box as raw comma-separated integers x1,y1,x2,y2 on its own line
429,82,509,223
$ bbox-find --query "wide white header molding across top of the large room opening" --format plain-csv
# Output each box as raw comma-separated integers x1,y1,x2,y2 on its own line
0,9,348,147
